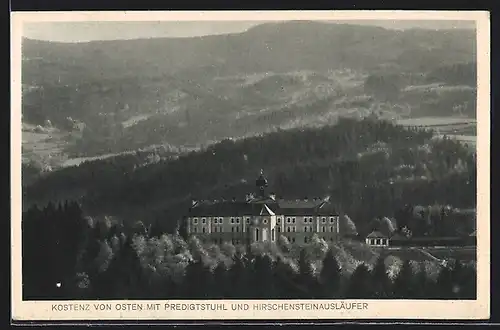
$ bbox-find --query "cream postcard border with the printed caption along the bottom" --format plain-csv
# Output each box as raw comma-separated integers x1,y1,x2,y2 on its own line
11,10,490,321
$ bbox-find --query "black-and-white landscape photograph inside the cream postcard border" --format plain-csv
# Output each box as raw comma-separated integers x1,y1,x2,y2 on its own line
12,10,489,322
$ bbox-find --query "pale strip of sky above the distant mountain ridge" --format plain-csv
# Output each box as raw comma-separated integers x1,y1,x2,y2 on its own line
23,20,475,42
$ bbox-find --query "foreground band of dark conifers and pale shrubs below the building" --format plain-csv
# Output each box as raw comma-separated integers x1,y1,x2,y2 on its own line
22,202,476,300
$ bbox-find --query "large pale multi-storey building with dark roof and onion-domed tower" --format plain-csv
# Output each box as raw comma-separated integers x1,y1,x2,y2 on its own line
186,171,339,244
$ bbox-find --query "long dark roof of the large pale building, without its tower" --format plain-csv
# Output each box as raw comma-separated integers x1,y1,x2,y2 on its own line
189,197,337,217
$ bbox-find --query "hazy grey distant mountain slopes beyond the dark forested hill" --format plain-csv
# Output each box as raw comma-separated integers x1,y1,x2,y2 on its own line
22,21,476,166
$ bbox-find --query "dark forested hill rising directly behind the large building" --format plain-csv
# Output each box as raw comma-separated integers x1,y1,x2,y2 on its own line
23,118,476,236
